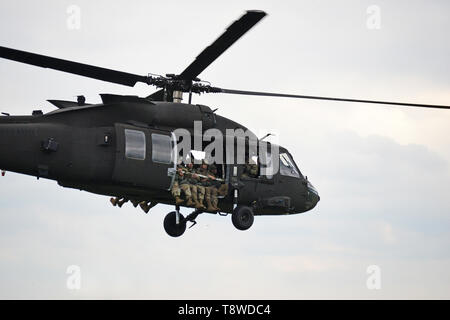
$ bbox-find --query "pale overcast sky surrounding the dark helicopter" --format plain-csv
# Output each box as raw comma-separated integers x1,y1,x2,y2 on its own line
0,0,450,299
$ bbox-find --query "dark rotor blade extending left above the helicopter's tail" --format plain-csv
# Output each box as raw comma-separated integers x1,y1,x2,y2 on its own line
0,46,147,87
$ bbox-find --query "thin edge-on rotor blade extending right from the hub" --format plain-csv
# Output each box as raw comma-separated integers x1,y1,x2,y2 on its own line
217,88,450,109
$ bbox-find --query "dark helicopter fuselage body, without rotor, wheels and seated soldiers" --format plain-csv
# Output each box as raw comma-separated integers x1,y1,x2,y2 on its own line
0,95,320,215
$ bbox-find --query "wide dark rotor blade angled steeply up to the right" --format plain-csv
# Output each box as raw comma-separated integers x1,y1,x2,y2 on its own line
178,11,266,80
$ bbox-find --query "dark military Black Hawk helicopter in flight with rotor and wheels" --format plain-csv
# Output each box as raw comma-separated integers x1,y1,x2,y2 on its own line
0,11,450,237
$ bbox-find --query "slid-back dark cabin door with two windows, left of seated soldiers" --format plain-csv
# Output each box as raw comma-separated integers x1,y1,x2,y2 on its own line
113,124,176,190
